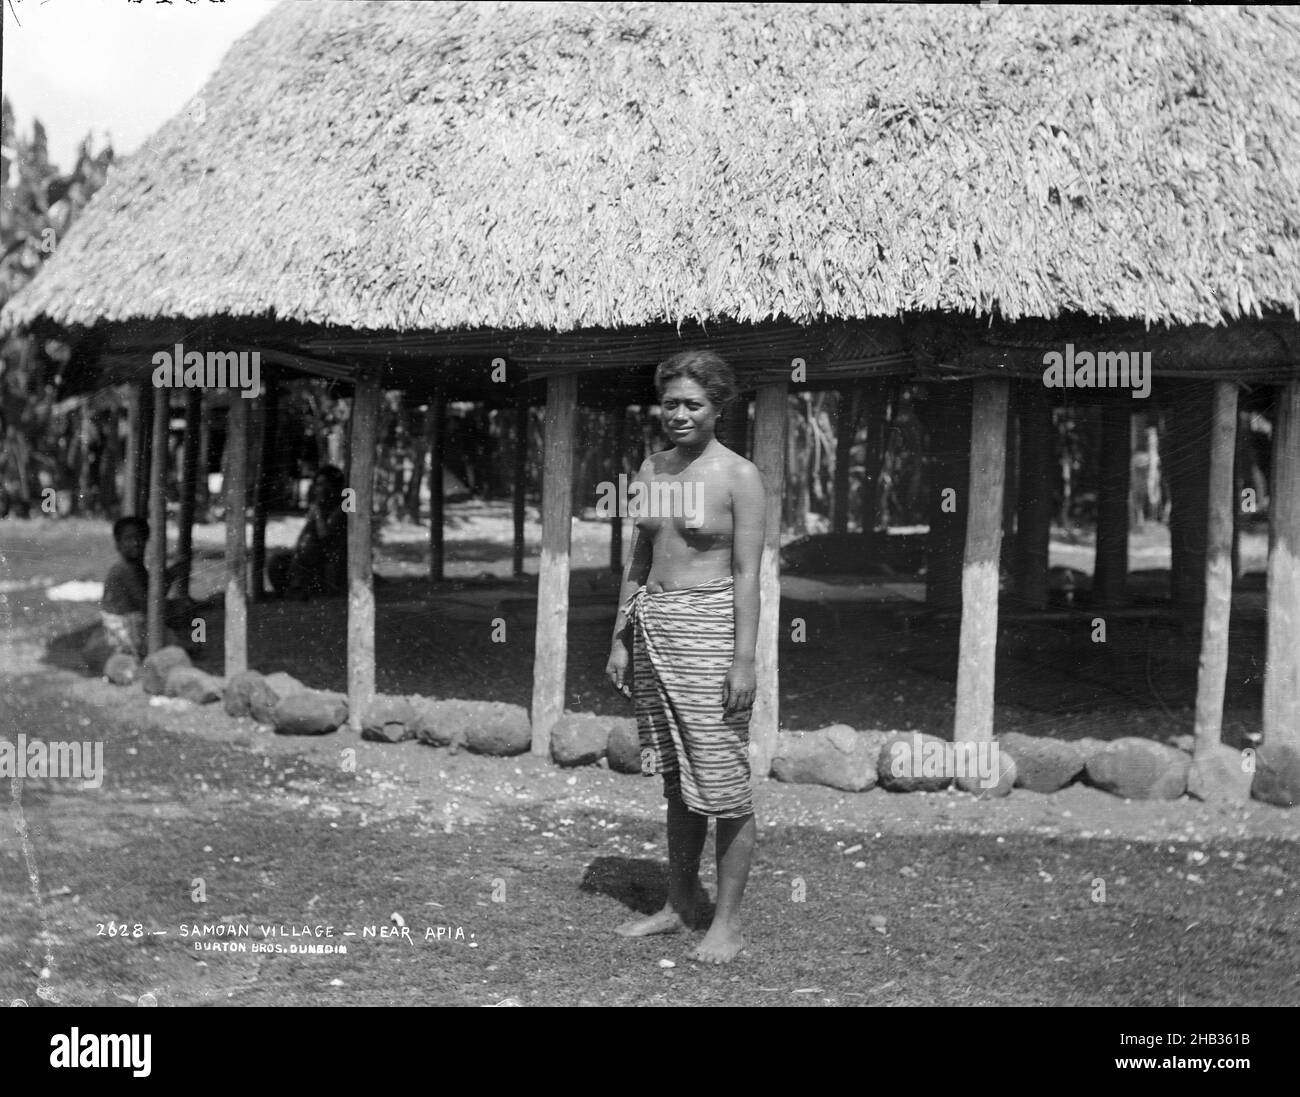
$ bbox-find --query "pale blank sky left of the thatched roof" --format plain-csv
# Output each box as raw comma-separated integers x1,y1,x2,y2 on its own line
0,0,279,172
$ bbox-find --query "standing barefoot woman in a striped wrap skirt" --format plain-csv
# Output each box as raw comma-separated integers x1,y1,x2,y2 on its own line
606,351,764,963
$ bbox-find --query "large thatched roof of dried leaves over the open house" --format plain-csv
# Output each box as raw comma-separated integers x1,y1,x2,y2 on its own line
7,3,1300,331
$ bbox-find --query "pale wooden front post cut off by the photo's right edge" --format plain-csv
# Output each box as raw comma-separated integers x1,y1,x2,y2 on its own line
1264,381,1300,750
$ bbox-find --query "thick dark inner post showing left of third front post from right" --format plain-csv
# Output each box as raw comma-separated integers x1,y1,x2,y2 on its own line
920,383,972,610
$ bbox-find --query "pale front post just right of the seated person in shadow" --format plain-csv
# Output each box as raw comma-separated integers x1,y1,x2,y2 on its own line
347,373,382,732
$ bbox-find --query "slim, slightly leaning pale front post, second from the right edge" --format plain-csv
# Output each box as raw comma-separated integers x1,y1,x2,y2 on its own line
1195,381,1236,755
